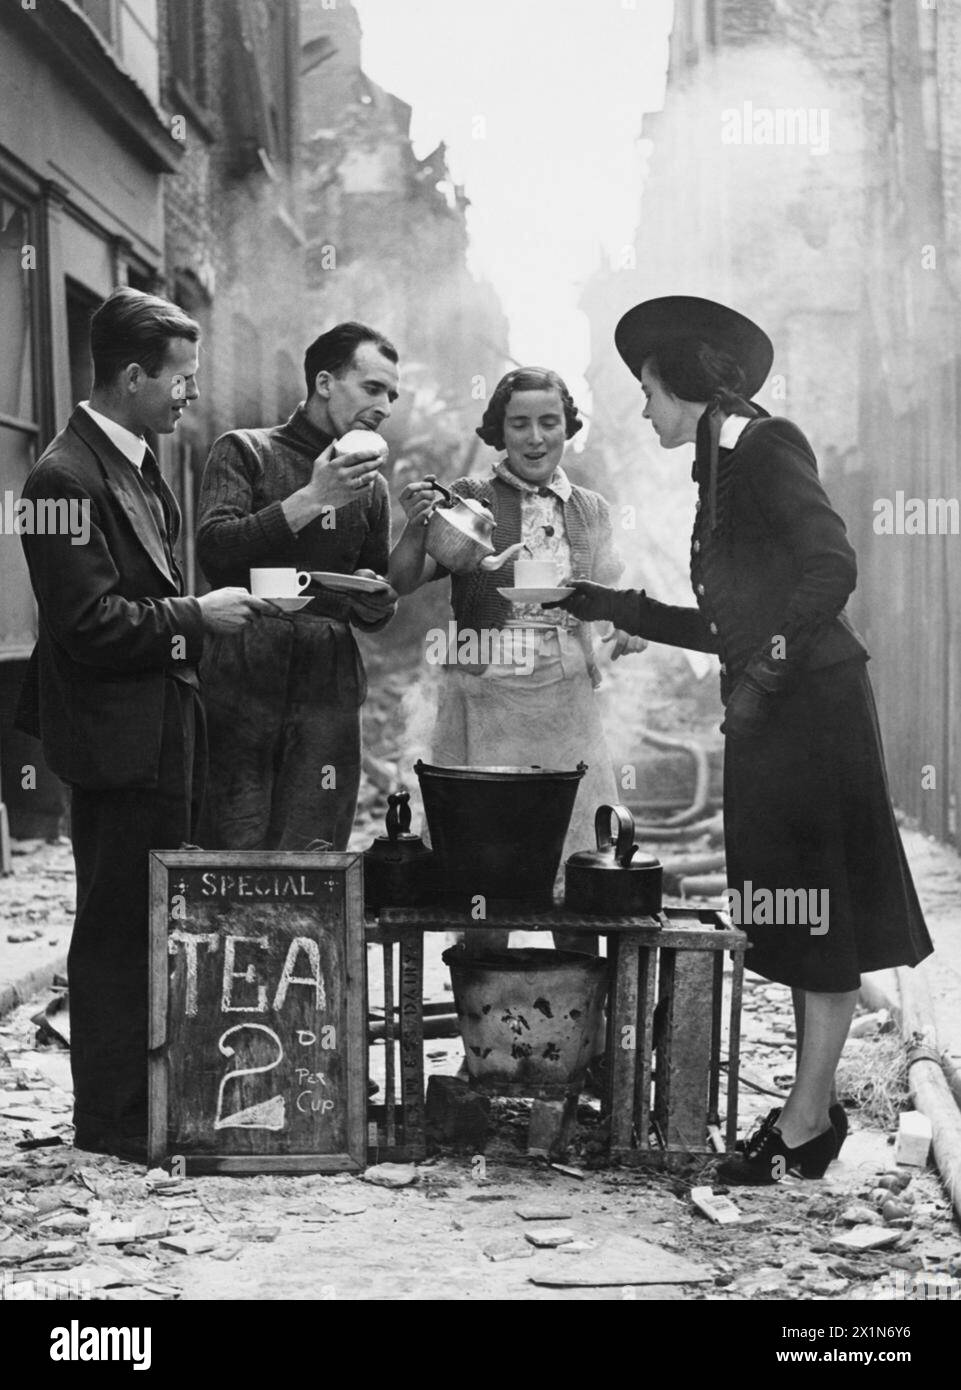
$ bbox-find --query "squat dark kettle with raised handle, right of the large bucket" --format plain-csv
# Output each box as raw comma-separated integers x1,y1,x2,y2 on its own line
565,806,663,917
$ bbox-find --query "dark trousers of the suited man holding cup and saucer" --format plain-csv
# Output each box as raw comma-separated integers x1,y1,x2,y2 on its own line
67,680,206,1137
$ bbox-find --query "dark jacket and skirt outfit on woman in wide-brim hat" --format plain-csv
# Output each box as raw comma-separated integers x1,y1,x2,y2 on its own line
613,417,932,992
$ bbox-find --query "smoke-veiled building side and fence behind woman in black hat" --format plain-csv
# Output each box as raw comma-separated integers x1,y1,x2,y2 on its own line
583,0,961,842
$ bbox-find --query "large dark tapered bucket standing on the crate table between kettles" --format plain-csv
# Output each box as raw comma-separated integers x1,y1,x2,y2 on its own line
414,762,587,908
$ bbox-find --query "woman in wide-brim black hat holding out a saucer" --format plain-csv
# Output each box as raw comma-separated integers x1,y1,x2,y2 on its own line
547,296,932,1183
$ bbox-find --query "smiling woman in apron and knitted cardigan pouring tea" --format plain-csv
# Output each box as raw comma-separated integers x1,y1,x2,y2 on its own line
389,367,647,945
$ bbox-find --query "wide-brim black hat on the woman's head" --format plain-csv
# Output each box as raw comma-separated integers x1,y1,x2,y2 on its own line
613,295,775,399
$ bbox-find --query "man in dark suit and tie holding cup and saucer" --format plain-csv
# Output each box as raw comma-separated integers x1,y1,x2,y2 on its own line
18,288,271,1159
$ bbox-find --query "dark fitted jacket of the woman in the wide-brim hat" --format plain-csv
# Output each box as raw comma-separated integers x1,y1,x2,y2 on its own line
613,417,868,699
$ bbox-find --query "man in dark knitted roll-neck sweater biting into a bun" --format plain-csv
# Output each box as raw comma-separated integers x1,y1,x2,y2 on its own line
197,322,398,849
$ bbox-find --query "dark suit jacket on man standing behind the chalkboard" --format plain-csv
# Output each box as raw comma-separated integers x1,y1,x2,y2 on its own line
17,407,203,790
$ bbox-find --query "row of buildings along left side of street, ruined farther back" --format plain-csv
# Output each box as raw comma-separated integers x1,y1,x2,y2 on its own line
0,0,506,842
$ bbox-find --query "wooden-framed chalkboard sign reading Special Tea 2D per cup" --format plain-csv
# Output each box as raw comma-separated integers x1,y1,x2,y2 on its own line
147,849,367,1173
